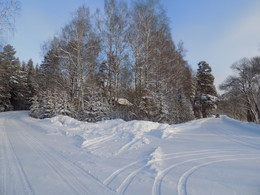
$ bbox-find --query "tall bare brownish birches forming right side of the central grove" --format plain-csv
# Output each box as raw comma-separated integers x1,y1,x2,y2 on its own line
129,0,192,122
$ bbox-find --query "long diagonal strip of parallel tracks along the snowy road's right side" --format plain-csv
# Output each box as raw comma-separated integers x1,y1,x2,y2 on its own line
7,117,114,194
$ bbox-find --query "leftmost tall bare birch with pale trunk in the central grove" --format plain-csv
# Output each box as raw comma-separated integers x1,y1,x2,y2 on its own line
58,6,99,110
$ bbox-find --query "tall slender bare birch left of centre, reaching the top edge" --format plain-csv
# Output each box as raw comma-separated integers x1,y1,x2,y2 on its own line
97,0,128,101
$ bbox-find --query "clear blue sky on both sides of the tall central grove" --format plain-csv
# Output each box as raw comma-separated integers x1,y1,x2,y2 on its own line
7,0,260,90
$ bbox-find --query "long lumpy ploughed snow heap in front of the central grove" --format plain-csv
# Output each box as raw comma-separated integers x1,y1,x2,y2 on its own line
49,116,175,157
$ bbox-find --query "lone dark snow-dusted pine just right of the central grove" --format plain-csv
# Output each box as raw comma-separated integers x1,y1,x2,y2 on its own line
194,61,217,118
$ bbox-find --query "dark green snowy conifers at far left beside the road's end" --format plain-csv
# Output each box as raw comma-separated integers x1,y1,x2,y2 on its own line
0,45,37,111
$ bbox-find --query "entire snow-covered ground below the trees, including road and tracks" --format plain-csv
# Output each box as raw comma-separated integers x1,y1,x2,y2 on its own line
0,112,260,195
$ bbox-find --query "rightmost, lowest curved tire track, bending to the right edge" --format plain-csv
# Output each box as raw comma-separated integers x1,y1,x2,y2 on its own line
177,158,260,195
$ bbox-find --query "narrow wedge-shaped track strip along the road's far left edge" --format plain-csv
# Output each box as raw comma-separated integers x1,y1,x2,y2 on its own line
1,119,35,194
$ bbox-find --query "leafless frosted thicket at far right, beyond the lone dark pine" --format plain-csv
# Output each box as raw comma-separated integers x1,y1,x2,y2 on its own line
219,57,260,123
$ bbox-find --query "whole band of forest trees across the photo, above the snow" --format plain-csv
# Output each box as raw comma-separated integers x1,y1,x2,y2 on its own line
0,0,260,124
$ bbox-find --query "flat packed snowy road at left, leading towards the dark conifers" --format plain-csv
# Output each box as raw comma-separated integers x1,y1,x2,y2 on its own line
0,113,113,195
